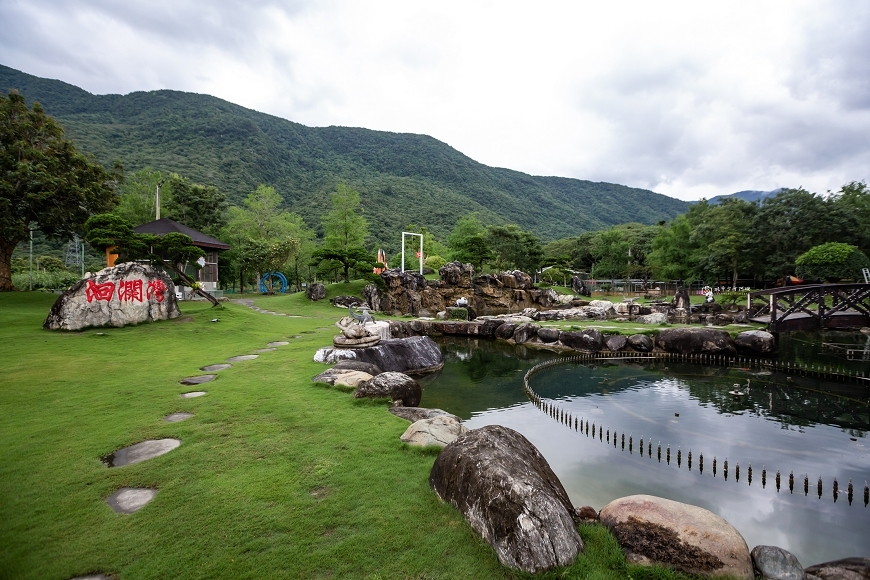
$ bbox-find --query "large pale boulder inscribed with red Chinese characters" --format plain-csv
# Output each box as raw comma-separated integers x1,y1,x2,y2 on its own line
42,262,180,330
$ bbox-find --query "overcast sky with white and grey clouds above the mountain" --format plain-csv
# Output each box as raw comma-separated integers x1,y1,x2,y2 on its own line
0,0,870,199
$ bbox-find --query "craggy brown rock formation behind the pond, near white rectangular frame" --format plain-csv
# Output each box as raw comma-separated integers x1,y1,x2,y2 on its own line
363,262,558,319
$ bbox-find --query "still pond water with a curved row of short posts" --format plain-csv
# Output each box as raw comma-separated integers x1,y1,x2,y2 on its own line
421,333,870,566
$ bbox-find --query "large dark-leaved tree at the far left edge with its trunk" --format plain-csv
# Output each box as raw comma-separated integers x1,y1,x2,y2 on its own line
0,92,117,291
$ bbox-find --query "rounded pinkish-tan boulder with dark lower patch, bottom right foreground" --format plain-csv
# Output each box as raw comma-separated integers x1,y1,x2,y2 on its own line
599,495,755,580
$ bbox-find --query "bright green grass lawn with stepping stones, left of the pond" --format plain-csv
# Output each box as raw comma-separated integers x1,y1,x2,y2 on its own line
0,283,704,579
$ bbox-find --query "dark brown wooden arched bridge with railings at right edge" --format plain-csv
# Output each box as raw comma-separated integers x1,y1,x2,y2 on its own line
746,284,870,333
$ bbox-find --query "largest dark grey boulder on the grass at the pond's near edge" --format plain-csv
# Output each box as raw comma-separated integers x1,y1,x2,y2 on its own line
429,425,583,572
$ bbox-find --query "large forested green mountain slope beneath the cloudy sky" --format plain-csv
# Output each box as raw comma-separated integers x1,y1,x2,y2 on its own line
0,65,688,249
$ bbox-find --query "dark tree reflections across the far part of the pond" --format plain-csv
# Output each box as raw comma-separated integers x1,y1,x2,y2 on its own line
427,338,870,437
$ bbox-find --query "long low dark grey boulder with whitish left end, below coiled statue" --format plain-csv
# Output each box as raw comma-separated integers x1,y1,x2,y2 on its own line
314,336,444,374
